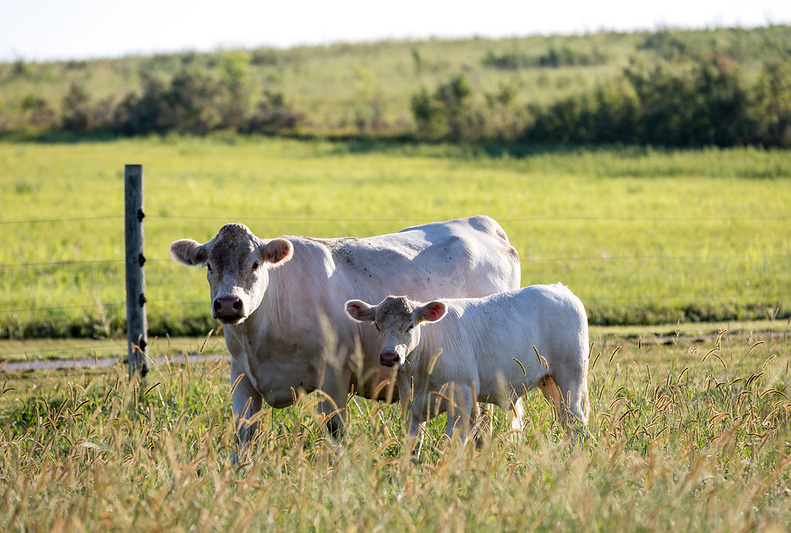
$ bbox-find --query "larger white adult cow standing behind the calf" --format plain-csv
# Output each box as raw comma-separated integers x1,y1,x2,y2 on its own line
170,216,520,442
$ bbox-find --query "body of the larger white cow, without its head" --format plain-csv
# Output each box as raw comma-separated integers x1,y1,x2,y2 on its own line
235,216,520,403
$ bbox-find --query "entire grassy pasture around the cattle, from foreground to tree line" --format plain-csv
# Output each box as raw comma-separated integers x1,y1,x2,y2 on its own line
0,137,791,531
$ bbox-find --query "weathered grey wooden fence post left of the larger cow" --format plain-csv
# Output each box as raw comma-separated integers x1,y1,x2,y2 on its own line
124,165,148,379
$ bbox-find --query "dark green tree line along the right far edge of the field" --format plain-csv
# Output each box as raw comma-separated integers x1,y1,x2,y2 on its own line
411,56,791,147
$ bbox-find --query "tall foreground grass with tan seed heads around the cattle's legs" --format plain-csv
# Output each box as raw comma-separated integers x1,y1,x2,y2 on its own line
0,331,791,531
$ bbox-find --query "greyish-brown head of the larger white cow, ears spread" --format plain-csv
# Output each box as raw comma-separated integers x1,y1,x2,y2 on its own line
170,224,294,324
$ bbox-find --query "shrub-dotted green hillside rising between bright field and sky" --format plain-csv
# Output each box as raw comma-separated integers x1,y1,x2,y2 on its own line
0,26,791,145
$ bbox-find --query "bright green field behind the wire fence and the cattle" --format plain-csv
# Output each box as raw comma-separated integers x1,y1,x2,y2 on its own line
0,137,791,338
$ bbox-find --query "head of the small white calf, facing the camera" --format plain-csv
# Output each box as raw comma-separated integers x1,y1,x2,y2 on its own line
346,296,447,366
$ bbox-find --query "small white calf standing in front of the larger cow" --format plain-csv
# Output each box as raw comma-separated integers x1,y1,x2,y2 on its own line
346,284,590,440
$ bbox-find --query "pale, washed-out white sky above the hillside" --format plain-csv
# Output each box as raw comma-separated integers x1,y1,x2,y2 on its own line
0,0,791,61
